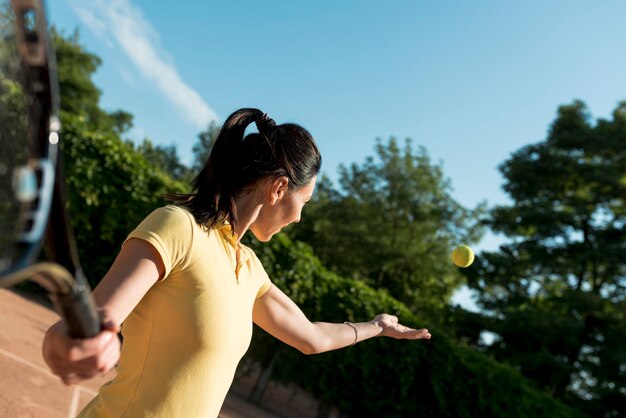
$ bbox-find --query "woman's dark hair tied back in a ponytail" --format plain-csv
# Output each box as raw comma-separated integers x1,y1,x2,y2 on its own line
168,109,322,228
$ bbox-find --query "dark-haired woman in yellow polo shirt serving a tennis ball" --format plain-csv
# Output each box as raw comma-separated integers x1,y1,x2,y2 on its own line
43,109,430,417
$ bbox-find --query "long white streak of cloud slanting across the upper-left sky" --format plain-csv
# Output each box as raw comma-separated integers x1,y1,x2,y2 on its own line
71,0,218,128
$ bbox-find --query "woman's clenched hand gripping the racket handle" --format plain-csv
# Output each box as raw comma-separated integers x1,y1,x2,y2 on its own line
42,320,121,385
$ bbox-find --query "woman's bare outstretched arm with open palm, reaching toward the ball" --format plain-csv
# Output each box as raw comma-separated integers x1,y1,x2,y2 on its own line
253,285,430,354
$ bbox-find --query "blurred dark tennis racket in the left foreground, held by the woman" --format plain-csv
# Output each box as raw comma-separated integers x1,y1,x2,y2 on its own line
0,0,101,338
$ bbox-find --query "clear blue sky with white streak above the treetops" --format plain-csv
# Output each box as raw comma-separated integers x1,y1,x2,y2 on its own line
48,0,626,306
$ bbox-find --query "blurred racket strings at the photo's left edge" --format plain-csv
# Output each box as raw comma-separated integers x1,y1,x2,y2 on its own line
0,8,49,271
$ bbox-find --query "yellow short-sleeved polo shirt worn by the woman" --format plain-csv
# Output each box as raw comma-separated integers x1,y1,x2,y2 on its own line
79,206,271,418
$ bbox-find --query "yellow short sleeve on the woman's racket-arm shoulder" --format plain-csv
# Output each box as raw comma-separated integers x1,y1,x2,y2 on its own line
124,206,194,279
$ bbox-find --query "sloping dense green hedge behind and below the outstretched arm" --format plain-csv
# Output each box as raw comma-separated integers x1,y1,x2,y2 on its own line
243,235,581,418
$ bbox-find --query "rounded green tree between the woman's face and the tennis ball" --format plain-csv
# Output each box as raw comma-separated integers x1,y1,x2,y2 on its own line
289,138,483,313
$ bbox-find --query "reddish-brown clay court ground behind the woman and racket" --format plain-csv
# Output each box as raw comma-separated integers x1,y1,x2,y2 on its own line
0,289,324,418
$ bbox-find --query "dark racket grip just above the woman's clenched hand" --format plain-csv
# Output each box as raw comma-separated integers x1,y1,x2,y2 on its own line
54,286,102,338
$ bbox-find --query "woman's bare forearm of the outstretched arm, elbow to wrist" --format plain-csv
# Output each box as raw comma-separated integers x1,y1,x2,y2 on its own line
307,321,383,354
